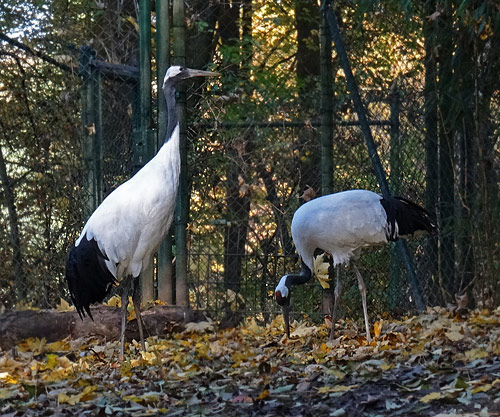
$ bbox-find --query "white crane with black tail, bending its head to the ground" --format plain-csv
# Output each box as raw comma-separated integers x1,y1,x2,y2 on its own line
275,190,436,341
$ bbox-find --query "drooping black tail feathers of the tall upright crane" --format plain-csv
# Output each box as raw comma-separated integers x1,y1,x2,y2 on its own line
66,236,115,320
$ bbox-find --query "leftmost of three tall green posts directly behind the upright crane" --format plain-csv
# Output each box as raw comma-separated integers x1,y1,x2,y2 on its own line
134,0,155,300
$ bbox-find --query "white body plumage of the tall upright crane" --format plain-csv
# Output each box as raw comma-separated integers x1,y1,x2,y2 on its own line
75,125,180,279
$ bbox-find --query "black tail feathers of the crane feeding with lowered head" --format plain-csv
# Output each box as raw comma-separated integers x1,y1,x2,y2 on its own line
380,197,437,241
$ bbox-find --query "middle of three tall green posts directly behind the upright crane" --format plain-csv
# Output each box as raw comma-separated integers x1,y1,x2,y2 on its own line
156,0,175,304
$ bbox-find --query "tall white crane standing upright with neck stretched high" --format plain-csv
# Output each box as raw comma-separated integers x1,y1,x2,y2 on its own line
66,66,218,357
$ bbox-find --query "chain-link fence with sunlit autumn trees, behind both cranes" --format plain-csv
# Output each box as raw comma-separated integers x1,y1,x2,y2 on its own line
0,0,500,328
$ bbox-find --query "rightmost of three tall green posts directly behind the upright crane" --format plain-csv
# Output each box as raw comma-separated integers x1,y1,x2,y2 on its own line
172,0,189,306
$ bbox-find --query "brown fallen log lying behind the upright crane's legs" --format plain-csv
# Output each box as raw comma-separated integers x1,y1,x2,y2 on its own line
0,305,200,349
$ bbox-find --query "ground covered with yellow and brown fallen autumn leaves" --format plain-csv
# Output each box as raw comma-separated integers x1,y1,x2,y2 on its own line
0,309,500,417
